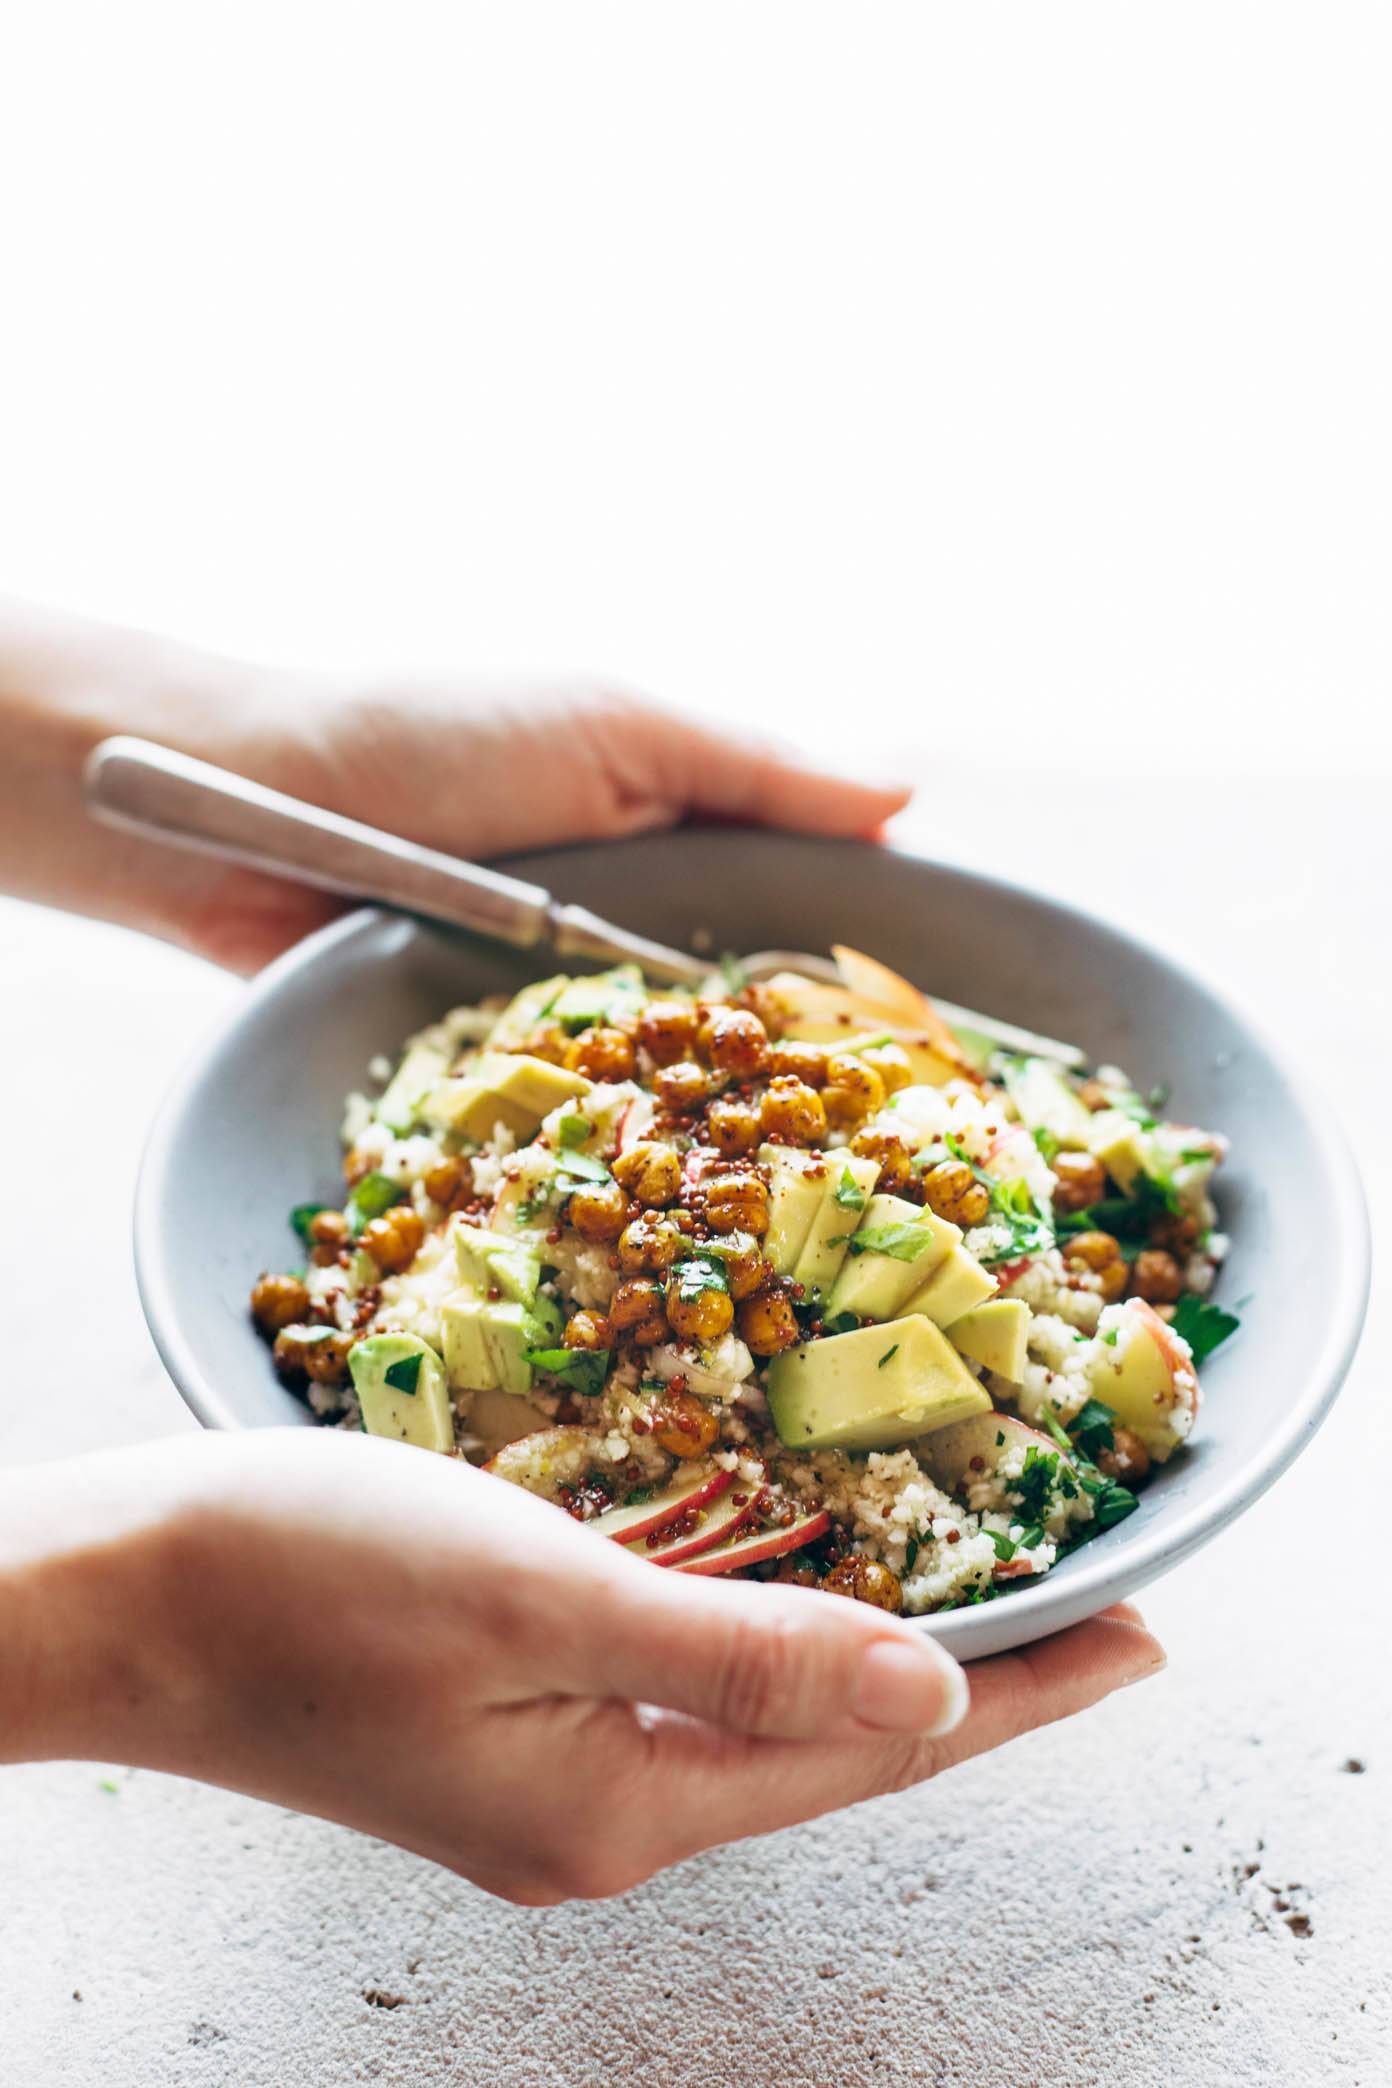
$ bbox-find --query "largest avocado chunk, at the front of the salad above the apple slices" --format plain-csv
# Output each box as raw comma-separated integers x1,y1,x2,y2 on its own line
768,1318,991,1449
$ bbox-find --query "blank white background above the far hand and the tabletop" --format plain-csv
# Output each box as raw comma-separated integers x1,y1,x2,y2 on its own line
0,0,1392,787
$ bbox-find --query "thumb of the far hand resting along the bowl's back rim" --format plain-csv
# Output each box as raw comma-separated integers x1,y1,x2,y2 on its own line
592,712,912,835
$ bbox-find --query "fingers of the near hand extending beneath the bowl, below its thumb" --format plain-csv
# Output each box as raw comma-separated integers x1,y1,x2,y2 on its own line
630,1612,1165,1869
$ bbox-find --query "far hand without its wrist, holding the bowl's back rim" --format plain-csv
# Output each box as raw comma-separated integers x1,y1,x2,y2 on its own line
114,674,910,971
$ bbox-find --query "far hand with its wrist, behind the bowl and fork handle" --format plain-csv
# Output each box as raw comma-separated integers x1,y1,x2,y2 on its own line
0,603,908,971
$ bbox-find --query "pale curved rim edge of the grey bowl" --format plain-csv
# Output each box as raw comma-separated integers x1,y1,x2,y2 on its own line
134,844,1371,1658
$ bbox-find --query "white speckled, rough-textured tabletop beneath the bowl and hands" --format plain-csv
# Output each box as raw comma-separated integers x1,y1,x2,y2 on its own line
0,783,1392,2088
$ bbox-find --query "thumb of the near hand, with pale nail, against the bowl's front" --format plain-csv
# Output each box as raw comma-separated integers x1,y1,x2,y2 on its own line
550,1556,968,1739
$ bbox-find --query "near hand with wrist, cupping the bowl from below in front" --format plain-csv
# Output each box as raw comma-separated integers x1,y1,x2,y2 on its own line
0,1430,1162,1906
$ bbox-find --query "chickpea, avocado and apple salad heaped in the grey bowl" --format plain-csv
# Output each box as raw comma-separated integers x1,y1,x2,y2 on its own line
250,950,1238,1614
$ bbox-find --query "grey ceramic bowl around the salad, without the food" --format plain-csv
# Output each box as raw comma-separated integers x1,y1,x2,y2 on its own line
136,829,1369,1658
